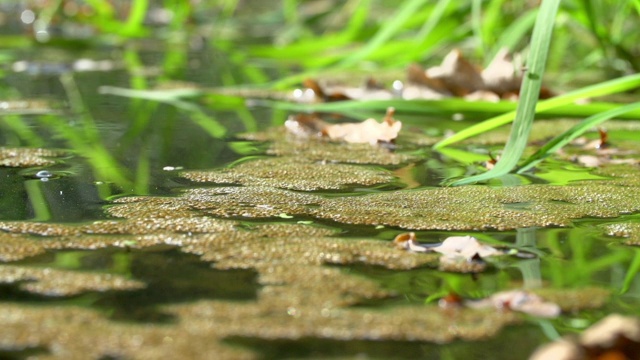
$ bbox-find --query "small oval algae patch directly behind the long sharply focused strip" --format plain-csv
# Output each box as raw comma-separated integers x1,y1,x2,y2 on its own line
182,157,394,191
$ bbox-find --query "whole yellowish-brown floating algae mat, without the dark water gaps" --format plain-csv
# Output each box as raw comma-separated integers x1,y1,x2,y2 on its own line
0,119,640,358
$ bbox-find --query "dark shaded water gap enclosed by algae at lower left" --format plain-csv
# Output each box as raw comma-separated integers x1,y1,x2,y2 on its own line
5,247,258,323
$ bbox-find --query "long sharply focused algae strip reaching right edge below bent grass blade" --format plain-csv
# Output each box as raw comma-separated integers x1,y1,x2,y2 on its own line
138,183,640,230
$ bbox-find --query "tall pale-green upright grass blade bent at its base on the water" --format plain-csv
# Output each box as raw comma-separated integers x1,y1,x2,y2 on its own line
444,0,560,185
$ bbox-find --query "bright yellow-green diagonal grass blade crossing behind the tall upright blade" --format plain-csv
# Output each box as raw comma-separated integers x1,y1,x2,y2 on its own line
433,74,640,149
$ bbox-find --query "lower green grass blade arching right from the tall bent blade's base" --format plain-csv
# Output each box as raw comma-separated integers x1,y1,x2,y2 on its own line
518,102,640,173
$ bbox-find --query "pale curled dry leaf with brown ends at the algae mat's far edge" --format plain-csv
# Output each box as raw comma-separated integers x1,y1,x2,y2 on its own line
285,108,402,145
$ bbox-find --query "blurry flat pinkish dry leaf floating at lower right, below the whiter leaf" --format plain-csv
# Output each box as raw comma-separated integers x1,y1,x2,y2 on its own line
465,290,561,318
